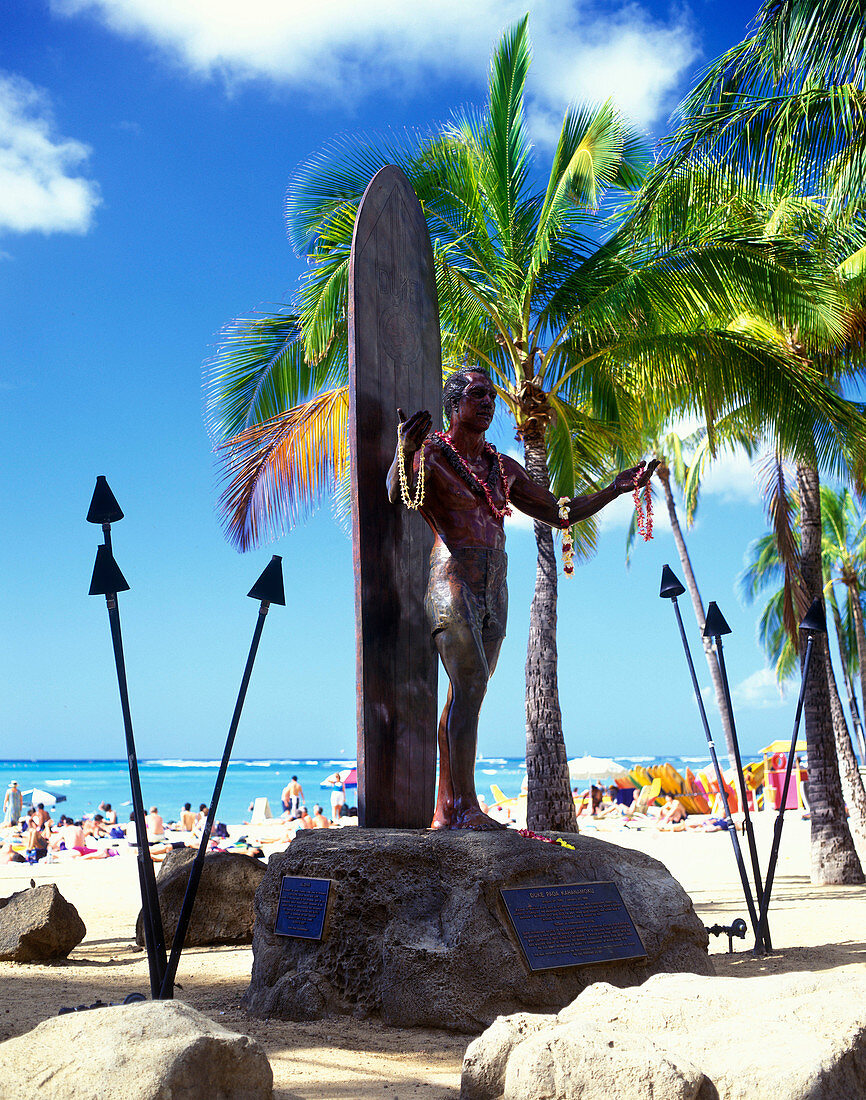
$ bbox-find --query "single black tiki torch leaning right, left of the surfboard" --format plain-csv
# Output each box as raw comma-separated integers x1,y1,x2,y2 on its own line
160,554,286,1000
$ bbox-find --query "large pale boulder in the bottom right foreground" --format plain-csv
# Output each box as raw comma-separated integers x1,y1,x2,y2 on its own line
460,974,866,1100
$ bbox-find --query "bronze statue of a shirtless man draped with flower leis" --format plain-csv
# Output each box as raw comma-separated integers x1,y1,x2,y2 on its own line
387,367,657,828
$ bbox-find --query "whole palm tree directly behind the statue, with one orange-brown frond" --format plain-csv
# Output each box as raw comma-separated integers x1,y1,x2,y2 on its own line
209,20,852,829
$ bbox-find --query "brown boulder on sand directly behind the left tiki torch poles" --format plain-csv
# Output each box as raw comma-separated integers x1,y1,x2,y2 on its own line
135,848,265,947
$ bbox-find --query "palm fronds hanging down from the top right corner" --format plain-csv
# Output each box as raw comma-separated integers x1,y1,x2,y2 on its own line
646,0,866,209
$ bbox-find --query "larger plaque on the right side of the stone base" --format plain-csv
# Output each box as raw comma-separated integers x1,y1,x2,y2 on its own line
500,882,646,970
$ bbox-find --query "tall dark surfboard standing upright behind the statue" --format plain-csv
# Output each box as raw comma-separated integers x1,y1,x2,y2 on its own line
349,166,442,828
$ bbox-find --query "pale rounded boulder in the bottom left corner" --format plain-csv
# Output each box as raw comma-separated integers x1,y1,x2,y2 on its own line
0,1001,274,1100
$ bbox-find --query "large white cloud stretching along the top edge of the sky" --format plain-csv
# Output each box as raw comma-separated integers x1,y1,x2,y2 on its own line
52,0,697,128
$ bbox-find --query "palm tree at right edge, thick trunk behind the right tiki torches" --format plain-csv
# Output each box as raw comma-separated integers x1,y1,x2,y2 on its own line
635,118,863,882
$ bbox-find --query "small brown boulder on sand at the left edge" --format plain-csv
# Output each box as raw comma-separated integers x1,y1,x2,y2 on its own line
0,882,87,963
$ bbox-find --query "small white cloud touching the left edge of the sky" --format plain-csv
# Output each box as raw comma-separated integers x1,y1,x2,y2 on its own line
0,73,99,233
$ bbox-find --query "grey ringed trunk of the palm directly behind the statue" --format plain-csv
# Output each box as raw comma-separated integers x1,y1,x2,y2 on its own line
524,429,578,833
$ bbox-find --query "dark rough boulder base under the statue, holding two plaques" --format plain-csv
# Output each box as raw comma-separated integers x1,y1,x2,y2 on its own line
244,828,713,1034
